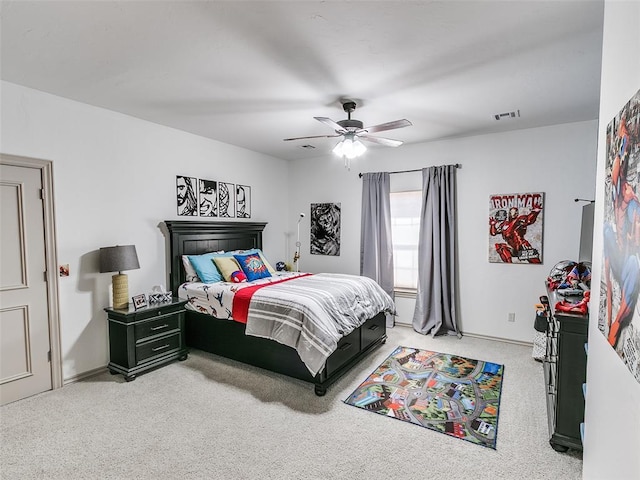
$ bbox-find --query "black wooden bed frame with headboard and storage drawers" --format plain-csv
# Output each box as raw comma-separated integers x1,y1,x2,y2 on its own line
164,220,387,396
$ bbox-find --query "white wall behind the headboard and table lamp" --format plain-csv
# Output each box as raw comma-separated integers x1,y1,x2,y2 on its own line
0,82,288,380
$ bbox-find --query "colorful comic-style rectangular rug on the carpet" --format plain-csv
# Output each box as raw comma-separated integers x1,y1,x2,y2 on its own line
344,347,504,450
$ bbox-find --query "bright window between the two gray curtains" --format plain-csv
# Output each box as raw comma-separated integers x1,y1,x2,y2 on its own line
390,190,422,292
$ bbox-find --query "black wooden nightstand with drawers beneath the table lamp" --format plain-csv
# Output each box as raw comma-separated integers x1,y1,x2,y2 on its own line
104,298,189,382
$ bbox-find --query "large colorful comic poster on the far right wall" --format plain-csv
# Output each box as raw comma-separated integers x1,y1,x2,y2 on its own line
598,91,640,383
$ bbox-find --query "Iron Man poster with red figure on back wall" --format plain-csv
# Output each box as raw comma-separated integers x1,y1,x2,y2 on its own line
489,192,544,264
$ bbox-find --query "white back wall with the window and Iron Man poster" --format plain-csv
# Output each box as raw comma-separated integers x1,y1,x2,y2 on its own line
289,121,597,342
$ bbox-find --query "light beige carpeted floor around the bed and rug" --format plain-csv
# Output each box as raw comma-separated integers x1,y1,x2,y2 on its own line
0,327,582,480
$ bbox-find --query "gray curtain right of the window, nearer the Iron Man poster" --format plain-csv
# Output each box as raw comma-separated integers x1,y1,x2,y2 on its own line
413,165,460,337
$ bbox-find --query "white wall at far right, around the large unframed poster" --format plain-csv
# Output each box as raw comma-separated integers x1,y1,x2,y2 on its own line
583,1,640,480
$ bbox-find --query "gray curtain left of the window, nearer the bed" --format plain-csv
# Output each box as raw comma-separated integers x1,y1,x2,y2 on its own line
360,172,395,327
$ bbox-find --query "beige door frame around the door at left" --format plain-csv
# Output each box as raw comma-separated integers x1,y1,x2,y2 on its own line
0,153,63,390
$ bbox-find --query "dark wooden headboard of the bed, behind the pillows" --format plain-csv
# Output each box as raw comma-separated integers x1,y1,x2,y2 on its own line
164,220,267,296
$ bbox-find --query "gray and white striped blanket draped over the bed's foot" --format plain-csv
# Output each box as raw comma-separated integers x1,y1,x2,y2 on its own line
246,273,395,376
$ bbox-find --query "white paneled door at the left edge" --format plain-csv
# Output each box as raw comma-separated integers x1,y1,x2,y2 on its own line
0,164,52,405
